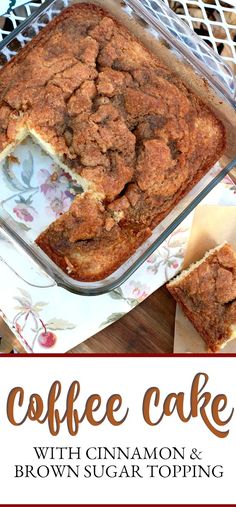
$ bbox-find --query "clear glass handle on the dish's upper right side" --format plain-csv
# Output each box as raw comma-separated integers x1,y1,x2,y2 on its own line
125,0,236,106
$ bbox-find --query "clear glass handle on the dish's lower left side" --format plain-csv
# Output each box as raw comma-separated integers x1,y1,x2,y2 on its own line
0,228,57,289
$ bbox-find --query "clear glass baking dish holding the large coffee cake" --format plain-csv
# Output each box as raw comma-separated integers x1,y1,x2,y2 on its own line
0,0,236,295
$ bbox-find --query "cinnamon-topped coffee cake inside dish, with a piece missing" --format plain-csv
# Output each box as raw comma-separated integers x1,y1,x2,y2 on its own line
0,4,225,281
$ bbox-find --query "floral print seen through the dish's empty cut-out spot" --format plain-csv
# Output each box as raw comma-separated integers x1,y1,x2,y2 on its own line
0,141,81,239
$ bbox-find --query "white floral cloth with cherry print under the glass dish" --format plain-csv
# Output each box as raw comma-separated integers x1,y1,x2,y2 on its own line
0,139,236,353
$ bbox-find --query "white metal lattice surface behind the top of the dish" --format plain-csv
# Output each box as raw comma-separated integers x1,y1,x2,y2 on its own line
0,0,236,67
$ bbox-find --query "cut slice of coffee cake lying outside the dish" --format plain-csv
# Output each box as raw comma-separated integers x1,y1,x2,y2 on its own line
167,244,236,352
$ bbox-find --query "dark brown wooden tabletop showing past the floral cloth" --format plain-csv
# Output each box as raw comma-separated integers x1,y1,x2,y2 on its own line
0,287,175,354
